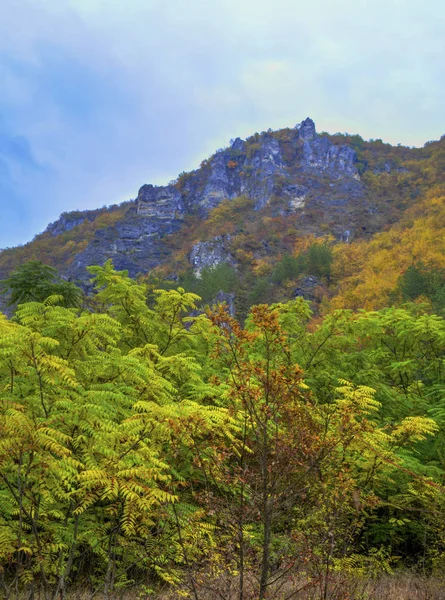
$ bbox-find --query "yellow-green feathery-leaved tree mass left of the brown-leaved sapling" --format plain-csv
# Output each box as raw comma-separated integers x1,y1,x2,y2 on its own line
0,265,232,600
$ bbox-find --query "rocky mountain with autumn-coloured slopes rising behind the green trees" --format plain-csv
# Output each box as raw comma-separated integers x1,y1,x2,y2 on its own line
0,118,445,314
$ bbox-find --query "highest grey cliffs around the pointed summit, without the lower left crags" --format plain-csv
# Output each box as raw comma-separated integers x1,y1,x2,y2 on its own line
177,118,358,217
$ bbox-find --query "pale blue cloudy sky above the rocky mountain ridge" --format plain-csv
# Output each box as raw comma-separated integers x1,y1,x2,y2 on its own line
0,0,445,248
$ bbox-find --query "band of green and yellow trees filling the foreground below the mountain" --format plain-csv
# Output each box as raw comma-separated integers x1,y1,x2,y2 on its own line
0,258,445,600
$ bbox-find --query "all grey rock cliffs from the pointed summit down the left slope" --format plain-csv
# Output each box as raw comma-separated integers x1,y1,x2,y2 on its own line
51,118,364,281
